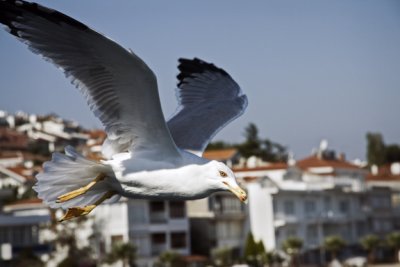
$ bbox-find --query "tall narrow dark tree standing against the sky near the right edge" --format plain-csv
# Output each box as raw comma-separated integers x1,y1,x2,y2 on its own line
366,133,385,166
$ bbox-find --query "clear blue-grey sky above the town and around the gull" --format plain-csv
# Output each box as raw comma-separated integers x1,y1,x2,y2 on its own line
0,0,400,159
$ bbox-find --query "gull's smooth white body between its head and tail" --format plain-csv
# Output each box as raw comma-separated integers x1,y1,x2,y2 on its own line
104,151,212,200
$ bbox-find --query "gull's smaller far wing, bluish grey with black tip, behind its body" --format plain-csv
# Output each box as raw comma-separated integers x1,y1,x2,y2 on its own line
168,58,247,155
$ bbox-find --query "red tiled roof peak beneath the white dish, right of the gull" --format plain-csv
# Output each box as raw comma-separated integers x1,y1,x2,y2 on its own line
296,155,360,170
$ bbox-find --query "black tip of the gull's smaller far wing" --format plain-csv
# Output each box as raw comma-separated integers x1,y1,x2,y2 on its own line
176,57,229,87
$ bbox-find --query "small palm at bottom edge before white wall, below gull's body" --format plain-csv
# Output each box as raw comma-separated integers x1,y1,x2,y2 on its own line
105,242,136,267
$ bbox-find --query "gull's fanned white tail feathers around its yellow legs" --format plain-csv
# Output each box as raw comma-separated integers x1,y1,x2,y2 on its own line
33,146,120,209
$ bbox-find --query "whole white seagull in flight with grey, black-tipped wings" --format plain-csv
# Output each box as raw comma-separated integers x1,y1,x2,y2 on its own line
0,0,248,221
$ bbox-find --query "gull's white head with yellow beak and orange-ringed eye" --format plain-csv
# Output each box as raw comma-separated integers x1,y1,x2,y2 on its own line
208,160,247,202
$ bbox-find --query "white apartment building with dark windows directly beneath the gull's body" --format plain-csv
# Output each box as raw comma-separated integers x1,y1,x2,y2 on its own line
93,200,190,267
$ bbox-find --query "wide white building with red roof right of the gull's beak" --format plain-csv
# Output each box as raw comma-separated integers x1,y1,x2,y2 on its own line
235,153,400,263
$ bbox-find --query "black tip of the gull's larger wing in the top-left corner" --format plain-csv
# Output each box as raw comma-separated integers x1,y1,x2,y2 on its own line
0,0,88,37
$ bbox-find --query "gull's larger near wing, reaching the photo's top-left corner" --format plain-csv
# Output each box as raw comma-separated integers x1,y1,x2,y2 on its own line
0,0,178,157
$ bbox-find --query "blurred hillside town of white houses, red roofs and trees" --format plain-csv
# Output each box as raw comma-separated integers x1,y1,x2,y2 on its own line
0,111,400,267
